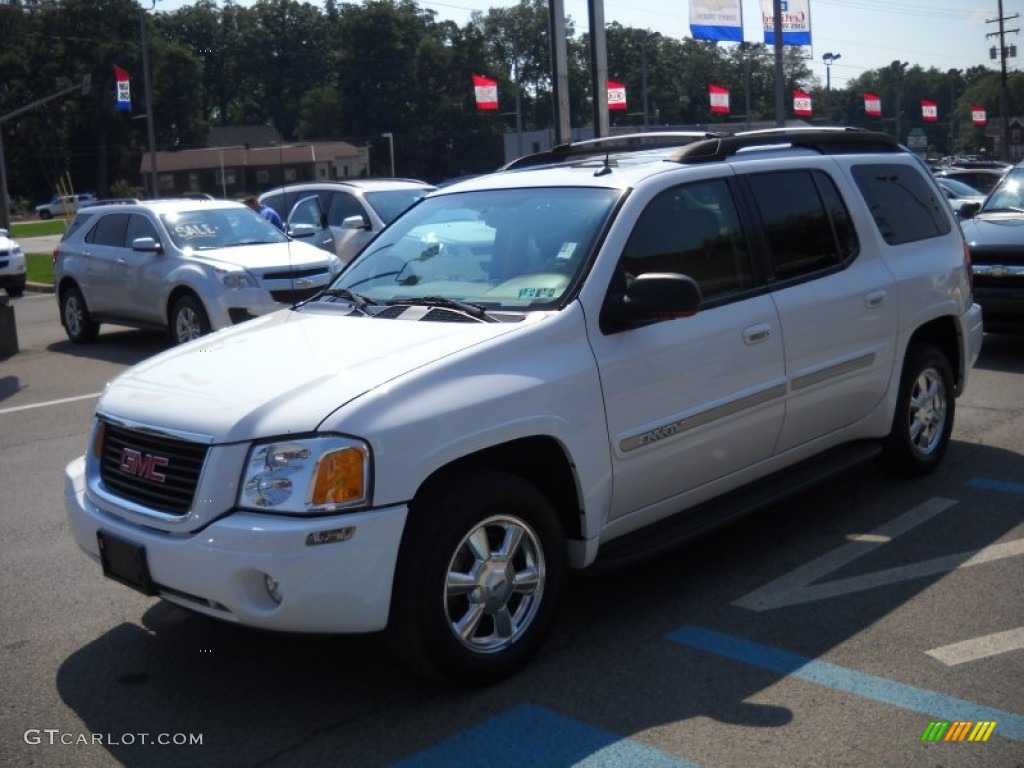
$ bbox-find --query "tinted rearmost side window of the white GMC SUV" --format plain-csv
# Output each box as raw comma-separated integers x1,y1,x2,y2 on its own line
853,163,952,246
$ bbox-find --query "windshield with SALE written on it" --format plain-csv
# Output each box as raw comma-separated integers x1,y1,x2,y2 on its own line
160,206,288,251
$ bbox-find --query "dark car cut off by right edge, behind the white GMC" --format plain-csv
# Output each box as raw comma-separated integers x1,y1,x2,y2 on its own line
961,160,1024,332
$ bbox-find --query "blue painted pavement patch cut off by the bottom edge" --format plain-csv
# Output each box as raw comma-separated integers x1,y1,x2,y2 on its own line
393,703,696,768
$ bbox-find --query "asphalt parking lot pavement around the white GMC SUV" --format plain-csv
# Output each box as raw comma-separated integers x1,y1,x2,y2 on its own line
0,294,1024,768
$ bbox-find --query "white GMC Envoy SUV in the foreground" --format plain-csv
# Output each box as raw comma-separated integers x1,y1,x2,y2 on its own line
66,130,982,683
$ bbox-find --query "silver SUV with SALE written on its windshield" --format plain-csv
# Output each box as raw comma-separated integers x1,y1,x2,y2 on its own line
53,200,341,343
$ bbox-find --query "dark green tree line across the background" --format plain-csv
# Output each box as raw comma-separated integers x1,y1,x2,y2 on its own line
0,0,1024,205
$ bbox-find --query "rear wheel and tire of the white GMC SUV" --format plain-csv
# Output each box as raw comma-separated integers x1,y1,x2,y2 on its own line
882,344,956,476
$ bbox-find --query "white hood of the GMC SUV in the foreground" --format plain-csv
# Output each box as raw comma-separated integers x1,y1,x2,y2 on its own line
97,307,528,442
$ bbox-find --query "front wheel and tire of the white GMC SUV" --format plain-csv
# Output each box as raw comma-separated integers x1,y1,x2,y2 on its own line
388,472,565,685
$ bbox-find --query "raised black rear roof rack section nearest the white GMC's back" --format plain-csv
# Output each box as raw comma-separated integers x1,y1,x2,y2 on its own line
666,128,900,163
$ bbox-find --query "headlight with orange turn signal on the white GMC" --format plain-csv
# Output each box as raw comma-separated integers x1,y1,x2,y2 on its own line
239,436,371,515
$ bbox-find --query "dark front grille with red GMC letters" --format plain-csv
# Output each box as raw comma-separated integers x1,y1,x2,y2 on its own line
99,422,208,515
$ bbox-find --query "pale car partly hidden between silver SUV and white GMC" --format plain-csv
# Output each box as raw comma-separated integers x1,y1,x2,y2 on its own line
259,179,434,264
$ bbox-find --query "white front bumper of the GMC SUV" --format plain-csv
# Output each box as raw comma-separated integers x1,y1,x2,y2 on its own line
65,457,409,633
